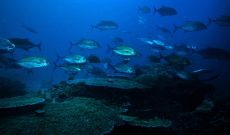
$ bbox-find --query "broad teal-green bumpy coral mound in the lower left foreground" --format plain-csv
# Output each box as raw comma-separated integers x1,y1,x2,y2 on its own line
0,98,123,135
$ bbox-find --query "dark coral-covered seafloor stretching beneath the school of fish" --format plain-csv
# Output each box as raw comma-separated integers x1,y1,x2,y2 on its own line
0,64,230,135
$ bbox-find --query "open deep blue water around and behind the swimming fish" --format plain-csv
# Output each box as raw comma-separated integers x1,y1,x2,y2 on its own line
0,0,230,95
